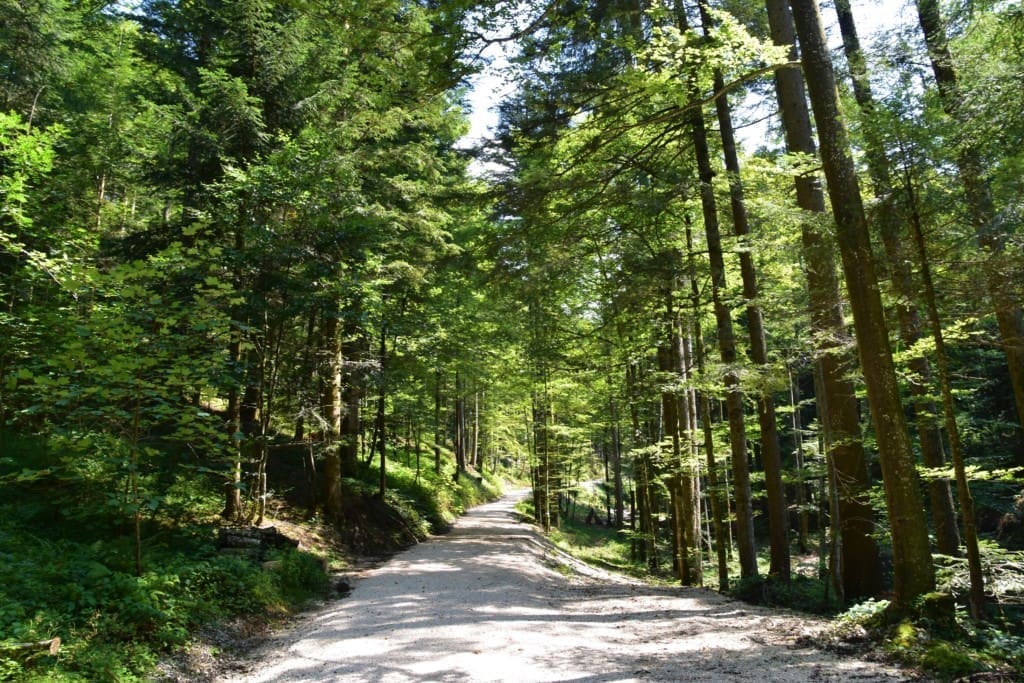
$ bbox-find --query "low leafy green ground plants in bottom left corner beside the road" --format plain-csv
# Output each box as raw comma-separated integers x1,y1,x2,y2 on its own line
0,528,328,680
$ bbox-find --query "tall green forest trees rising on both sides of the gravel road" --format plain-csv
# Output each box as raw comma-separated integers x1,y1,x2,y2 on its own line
0,0,1024,676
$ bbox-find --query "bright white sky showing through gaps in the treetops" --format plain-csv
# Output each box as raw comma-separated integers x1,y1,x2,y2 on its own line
463,0,916,152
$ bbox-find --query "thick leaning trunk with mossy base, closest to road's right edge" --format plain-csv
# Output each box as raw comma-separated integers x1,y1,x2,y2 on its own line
791,0,935,608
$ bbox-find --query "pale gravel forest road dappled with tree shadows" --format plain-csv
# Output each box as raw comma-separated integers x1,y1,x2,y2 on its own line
220,492,909,683
